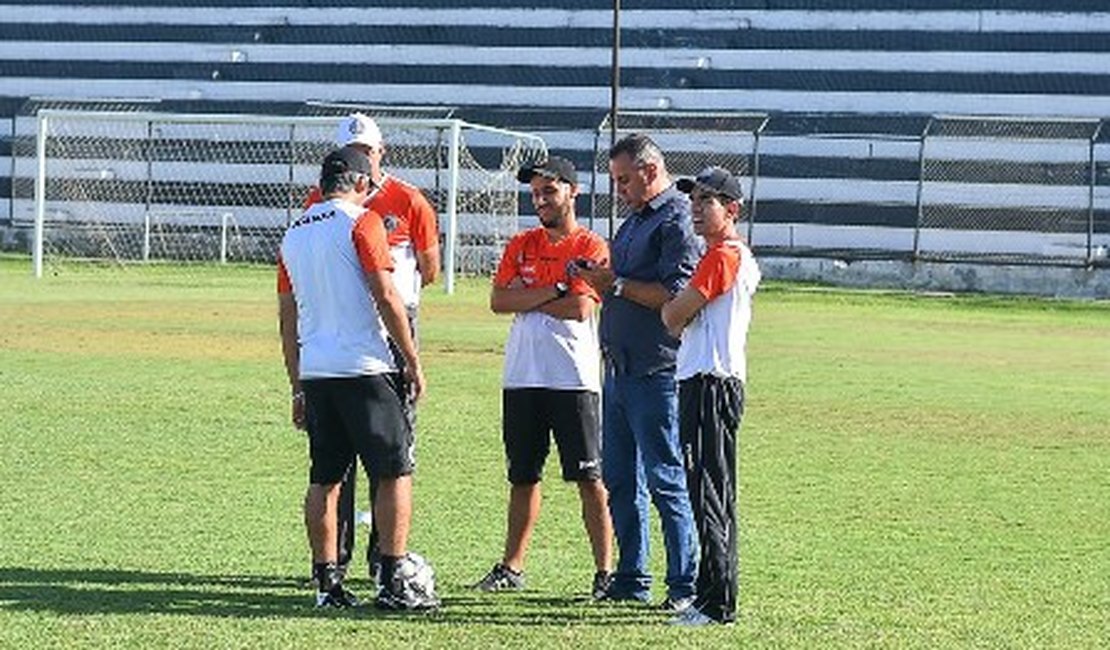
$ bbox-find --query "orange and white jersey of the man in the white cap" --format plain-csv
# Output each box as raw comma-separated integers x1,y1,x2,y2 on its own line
305,175,440,307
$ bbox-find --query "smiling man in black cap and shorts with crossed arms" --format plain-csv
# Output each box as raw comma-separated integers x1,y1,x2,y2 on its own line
474,156,613,598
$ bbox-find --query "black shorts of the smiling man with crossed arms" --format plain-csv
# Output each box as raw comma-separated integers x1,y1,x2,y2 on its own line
501,388,602,485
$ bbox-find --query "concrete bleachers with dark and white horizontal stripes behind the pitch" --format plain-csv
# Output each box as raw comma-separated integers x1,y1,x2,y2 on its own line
0,0,1110,266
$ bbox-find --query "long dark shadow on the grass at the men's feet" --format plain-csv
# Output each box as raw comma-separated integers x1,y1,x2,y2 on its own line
0,567,659,626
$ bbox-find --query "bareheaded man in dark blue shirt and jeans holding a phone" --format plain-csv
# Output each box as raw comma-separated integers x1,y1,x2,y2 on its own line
582,134,698,611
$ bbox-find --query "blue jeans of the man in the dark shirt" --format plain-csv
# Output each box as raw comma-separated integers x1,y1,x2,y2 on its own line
602,372,698,600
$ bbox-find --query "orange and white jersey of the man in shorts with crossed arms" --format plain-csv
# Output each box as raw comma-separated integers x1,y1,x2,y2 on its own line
493,226,609,393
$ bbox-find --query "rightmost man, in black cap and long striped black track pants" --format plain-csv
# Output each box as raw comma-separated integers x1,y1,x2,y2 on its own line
662,167,760,626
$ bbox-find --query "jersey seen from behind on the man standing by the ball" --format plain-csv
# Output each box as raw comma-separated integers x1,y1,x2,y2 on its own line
278,200,396,379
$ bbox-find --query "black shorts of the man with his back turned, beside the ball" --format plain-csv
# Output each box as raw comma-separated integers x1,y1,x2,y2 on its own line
301,373,413,485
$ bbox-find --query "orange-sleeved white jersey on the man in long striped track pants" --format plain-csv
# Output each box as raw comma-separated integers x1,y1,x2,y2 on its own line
676,240,763,382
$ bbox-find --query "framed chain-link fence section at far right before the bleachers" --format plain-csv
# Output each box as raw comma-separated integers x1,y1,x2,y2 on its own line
914,115,1106,264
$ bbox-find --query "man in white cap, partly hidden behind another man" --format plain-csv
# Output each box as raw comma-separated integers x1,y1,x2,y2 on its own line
305,113,440,581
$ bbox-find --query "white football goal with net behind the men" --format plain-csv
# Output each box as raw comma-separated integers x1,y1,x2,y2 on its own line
32,109,547,293
